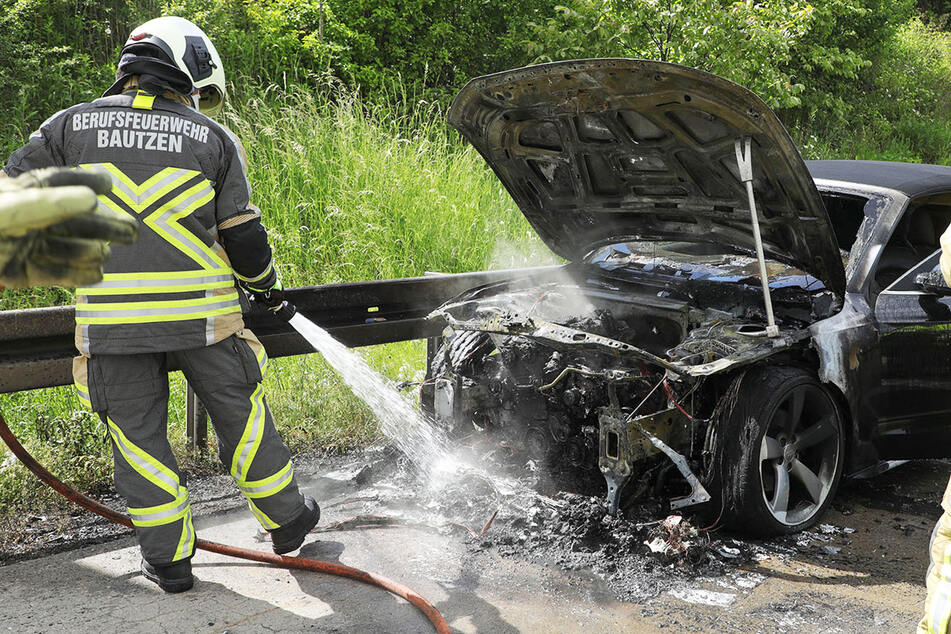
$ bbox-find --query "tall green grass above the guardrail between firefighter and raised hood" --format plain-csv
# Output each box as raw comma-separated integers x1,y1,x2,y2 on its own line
227,86,556,285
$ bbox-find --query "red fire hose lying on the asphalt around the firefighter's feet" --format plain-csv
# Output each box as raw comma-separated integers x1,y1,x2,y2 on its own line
0,414,449,634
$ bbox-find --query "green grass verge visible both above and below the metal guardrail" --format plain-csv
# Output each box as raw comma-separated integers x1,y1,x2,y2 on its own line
0,91,553,517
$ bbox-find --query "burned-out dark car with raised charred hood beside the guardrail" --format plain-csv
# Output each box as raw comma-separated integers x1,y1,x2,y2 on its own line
421,59,951,534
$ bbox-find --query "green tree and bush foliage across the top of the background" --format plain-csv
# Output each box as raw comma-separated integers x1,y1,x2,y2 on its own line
0,0,951,163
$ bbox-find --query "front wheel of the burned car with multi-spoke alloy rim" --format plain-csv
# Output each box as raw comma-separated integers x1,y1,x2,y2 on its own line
714,366,845,535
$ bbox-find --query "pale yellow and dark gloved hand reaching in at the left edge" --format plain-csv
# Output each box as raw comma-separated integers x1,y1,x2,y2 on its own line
0,167,136,287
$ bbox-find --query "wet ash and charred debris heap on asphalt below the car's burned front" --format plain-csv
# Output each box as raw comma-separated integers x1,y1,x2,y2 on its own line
365,446,796,602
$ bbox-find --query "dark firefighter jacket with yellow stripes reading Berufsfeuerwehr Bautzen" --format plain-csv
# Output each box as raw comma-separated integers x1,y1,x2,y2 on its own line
4,91,276,355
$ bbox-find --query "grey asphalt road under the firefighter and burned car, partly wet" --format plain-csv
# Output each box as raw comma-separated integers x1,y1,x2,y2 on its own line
0,452,951,634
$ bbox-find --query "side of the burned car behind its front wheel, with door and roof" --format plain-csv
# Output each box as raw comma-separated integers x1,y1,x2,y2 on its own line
808,161,951,460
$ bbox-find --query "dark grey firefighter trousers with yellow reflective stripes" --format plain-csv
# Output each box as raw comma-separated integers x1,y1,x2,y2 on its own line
73,330,306,565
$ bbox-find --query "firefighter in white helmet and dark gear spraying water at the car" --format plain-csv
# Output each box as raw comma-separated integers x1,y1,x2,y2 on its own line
4,17,320,592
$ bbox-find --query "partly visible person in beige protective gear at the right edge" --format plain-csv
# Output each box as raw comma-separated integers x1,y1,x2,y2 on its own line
918,222,951,634
